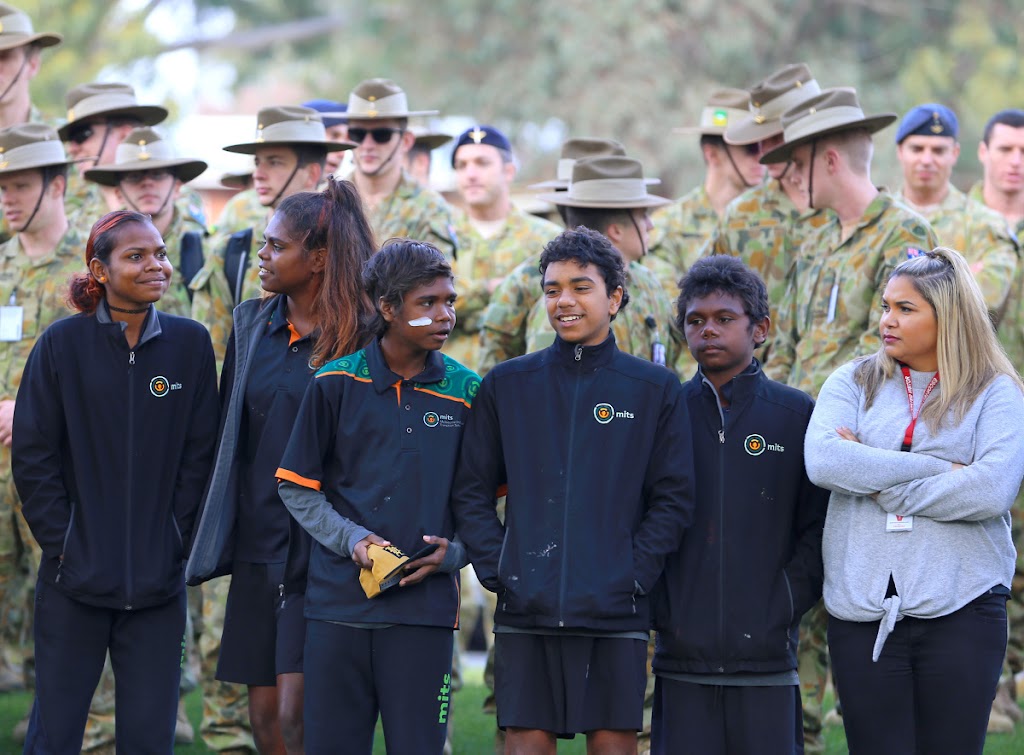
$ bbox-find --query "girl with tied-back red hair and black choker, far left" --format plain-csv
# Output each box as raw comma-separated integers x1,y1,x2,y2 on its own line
12,211,217,753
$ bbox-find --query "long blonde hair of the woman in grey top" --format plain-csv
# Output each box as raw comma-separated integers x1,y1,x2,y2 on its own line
854,247,1024,428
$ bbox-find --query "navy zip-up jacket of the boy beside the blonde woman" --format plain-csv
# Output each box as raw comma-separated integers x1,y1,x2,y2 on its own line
653,361,828,674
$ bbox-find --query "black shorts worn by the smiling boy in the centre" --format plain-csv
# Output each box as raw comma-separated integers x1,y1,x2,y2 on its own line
495,632,647,739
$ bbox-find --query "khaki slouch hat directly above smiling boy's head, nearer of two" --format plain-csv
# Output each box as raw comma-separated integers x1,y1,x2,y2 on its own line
537,155,672,210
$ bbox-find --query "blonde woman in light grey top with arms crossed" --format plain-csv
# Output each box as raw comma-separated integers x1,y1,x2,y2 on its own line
805,248,1024,755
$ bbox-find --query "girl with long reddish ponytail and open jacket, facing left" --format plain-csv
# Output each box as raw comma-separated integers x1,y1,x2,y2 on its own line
186,178,376,753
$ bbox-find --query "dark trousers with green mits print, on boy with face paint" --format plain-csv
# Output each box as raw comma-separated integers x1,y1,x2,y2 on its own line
302,619,454,755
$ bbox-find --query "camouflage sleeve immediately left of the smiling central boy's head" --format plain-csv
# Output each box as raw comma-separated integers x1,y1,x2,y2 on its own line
477,265,540,375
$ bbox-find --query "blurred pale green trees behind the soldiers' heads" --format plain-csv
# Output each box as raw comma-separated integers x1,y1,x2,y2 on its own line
14,0,1024,195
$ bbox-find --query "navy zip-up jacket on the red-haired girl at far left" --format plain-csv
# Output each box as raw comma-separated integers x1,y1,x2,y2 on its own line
11,302,218,611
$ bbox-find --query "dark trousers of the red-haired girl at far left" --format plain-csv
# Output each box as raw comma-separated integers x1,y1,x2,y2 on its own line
25,581,185,755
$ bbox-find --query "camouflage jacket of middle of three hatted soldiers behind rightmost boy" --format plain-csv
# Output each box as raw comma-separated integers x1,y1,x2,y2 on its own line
700,180,833,313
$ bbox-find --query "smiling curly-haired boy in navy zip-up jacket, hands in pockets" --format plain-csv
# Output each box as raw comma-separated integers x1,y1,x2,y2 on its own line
453,227,693,753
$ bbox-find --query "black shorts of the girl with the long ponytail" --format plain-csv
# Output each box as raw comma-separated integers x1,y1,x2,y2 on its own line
216,561,285,686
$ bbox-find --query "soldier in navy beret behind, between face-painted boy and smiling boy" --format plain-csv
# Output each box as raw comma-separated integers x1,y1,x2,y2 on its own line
444,126,561,370
